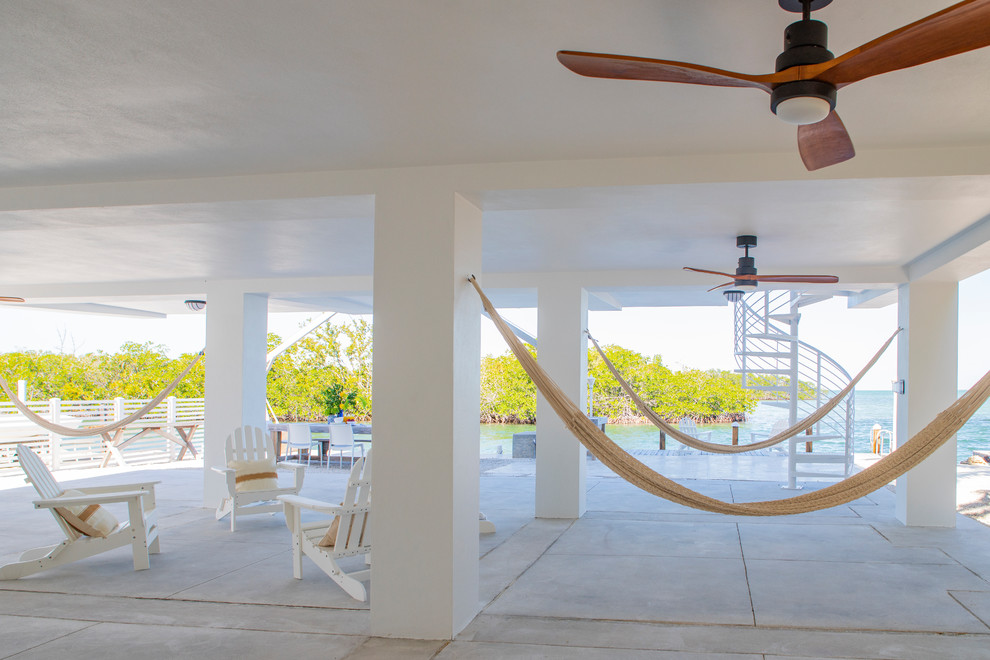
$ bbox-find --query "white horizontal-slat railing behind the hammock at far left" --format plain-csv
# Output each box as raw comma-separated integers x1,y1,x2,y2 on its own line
0,396,205,470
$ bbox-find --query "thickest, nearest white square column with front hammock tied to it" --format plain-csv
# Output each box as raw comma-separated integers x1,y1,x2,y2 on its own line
371,183,481,639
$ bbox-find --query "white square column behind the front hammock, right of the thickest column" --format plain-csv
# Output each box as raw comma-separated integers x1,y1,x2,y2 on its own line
536,275,588,518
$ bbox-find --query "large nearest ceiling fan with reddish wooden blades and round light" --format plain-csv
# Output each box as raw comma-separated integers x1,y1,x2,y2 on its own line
557,0,990,170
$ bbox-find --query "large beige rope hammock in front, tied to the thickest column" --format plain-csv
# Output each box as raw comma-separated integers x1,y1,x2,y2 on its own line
469,276,990,516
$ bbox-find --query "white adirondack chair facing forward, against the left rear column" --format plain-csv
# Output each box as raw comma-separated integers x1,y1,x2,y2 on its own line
213,426,306,532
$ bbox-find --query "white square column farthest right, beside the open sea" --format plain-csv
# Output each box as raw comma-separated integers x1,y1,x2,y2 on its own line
894,282,959,527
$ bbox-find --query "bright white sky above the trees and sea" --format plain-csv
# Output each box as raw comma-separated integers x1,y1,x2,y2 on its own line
0,271,990,390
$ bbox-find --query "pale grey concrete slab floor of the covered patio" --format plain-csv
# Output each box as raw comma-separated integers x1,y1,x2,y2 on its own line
0,456,990,660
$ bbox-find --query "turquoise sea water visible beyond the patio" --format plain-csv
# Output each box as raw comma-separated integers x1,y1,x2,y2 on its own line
481,390,990,460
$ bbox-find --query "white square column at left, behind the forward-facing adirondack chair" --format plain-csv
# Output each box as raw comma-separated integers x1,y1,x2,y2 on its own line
203,282,268,507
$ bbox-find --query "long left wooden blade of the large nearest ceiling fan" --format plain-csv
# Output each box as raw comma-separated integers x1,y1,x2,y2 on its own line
557,50,777,93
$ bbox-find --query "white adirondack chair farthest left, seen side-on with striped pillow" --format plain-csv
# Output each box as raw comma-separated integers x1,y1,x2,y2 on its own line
0,444,159,580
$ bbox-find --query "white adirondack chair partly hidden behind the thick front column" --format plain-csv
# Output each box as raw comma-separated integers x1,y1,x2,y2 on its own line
278,451,371,601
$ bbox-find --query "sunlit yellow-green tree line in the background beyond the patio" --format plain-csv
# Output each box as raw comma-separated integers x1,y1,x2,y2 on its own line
0,319,758,424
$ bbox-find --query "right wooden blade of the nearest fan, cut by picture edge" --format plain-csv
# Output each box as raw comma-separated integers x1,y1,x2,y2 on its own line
809,0,990,87
